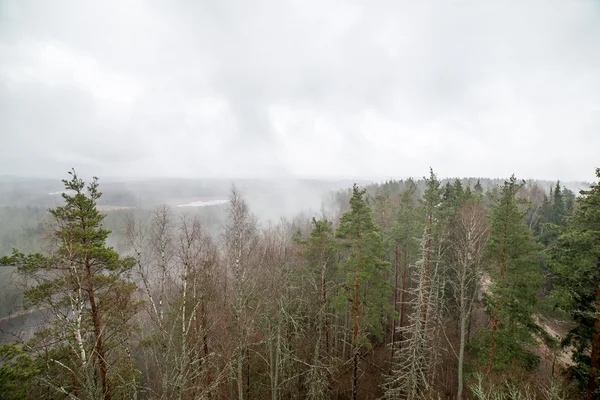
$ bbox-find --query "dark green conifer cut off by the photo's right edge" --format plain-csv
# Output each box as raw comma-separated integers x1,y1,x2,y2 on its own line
552,168,600,400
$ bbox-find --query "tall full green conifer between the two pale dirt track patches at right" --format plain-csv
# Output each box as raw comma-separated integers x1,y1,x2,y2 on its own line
482,175,541,372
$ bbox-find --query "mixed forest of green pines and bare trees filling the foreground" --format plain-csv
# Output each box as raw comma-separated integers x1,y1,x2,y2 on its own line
0,169,600,400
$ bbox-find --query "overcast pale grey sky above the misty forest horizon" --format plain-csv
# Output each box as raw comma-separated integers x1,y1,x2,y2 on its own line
0,0,600,181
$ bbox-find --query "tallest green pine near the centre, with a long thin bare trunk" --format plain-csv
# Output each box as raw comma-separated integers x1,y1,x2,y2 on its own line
336,184,391,399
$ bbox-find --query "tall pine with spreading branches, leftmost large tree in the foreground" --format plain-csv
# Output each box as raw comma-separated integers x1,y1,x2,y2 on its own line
0,170,138,400
